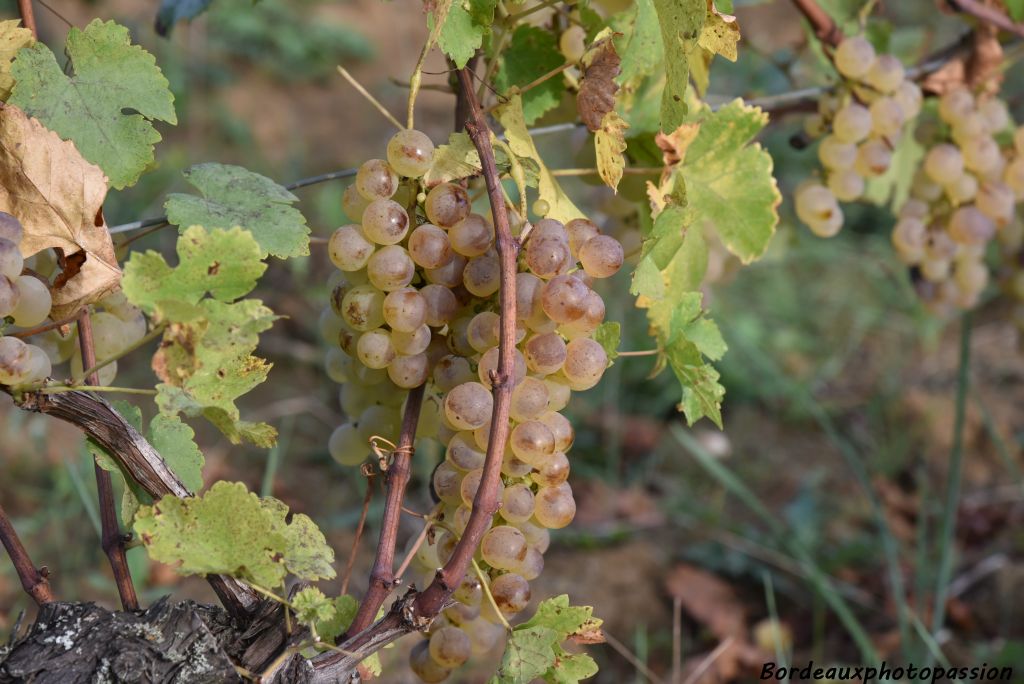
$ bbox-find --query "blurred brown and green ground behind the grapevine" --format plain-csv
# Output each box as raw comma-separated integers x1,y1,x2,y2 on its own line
0,0,1024,682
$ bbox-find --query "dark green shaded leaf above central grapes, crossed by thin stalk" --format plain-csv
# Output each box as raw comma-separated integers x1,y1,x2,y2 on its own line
495,25,565,125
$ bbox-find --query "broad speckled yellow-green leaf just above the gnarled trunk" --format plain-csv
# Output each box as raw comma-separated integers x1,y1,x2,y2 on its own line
135,481,335,589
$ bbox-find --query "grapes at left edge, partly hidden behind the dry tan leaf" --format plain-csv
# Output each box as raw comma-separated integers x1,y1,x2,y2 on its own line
0,212,147,386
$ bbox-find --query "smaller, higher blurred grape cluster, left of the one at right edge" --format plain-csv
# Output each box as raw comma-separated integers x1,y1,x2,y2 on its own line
796,36,922,238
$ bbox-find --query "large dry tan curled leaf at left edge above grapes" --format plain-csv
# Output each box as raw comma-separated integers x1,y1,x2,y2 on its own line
0,104,121,318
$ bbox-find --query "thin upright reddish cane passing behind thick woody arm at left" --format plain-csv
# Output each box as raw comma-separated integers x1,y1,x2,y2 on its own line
78,308,138,610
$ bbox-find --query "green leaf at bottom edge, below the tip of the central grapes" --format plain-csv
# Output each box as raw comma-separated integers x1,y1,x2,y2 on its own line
490,594,601,684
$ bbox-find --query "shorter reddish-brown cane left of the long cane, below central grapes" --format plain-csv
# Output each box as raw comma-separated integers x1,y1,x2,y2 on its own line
348,385,424,634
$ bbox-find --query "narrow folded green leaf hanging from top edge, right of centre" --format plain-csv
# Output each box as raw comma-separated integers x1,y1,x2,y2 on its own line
653,0,708,132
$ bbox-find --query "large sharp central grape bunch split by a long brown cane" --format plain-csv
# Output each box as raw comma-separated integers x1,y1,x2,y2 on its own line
321,130,624,682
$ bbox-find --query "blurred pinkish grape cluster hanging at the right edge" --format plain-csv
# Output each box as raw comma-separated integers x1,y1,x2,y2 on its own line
892,89,1024,312
